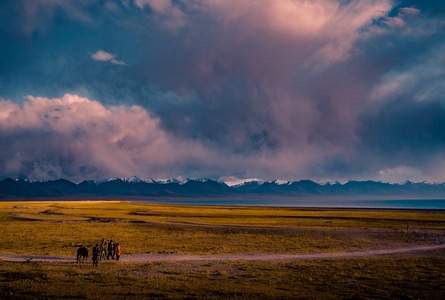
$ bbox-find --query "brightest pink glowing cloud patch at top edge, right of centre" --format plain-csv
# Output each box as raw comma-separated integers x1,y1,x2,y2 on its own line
202,0,392,66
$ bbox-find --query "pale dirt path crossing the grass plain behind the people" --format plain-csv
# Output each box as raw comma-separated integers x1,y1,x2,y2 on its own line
0,244,445,263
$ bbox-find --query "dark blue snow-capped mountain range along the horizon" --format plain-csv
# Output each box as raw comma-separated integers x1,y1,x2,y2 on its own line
0,176,445,200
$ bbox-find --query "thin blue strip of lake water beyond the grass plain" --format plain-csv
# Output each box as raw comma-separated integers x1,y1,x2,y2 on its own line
140,198,445,210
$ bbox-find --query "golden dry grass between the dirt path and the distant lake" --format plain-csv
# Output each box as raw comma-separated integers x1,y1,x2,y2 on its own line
0,202,445,255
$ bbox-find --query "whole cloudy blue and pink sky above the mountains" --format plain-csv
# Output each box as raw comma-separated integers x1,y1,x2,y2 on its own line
0,0,445,183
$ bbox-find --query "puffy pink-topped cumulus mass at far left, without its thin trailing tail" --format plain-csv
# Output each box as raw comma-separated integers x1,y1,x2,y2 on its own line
0,94,212,181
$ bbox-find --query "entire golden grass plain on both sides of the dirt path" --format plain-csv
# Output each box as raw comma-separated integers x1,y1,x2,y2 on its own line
0,201,445,299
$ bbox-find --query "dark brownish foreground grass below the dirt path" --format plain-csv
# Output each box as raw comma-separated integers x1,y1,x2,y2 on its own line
0,256,445,299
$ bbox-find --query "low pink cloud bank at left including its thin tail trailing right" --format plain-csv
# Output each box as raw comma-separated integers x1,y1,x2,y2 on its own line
0,94,354,181
